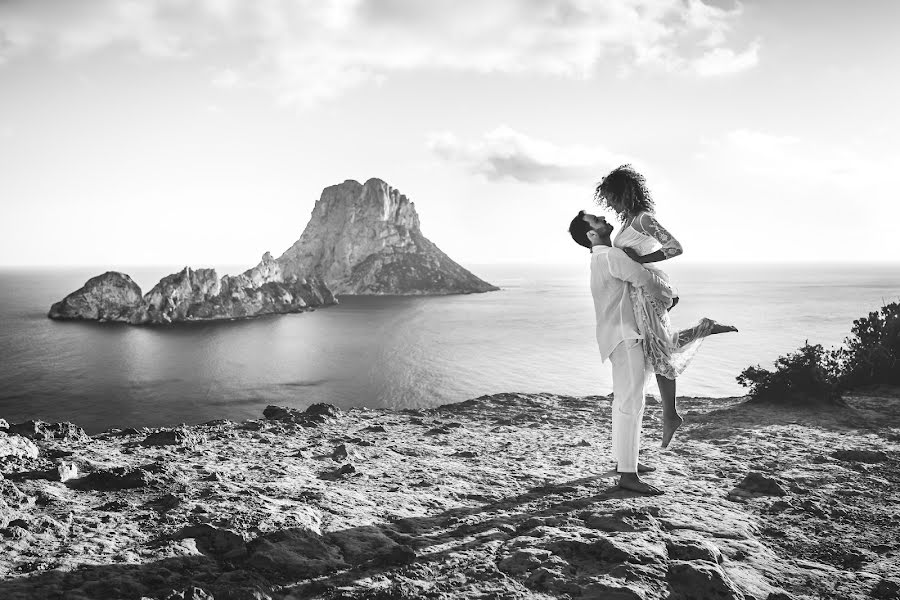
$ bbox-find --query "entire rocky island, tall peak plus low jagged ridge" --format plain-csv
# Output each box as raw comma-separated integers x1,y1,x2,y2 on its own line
47,179,498,325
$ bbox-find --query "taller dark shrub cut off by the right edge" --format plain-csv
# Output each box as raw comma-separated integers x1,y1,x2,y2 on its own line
836,302,900,388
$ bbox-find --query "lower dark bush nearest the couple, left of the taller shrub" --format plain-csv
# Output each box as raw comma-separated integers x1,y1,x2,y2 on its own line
737,342,840,404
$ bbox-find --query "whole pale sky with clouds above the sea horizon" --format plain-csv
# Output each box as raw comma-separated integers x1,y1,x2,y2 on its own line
0,0,900,268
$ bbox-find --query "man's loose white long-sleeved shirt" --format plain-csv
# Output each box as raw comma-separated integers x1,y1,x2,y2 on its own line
591,246,674,361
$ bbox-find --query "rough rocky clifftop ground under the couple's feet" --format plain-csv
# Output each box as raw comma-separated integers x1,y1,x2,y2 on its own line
0,393,900,600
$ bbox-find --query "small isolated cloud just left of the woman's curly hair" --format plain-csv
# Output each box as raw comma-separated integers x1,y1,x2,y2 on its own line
427,126,629,183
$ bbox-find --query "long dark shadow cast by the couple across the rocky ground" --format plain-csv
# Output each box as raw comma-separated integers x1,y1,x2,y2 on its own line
0,471,641,600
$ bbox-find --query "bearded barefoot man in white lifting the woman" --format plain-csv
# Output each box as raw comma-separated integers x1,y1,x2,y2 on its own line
569,211,673,494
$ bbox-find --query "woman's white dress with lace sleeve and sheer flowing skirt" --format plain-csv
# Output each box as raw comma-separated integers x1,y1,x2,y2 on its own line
613,213,714,379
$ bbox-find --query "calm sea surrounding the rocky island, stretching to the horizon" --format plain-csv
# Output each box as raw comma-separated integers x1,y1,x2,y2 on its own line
0,261,900,433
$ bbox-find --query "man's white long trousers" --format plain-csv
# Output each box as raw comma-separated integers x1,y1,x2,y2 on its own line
609,340,648,473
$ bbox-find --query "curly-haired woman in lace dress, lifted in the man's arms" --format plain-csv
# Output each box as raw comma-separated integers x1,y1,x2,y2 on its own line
594,165,737,448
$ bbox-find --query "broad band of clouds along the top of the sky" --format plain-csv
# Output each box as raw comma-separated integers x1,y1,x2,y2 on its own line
0,0,759,105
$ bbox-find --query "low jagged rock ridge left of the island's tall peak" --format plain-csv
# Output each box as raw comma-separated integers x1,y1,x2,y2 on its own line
47,252,337,325
